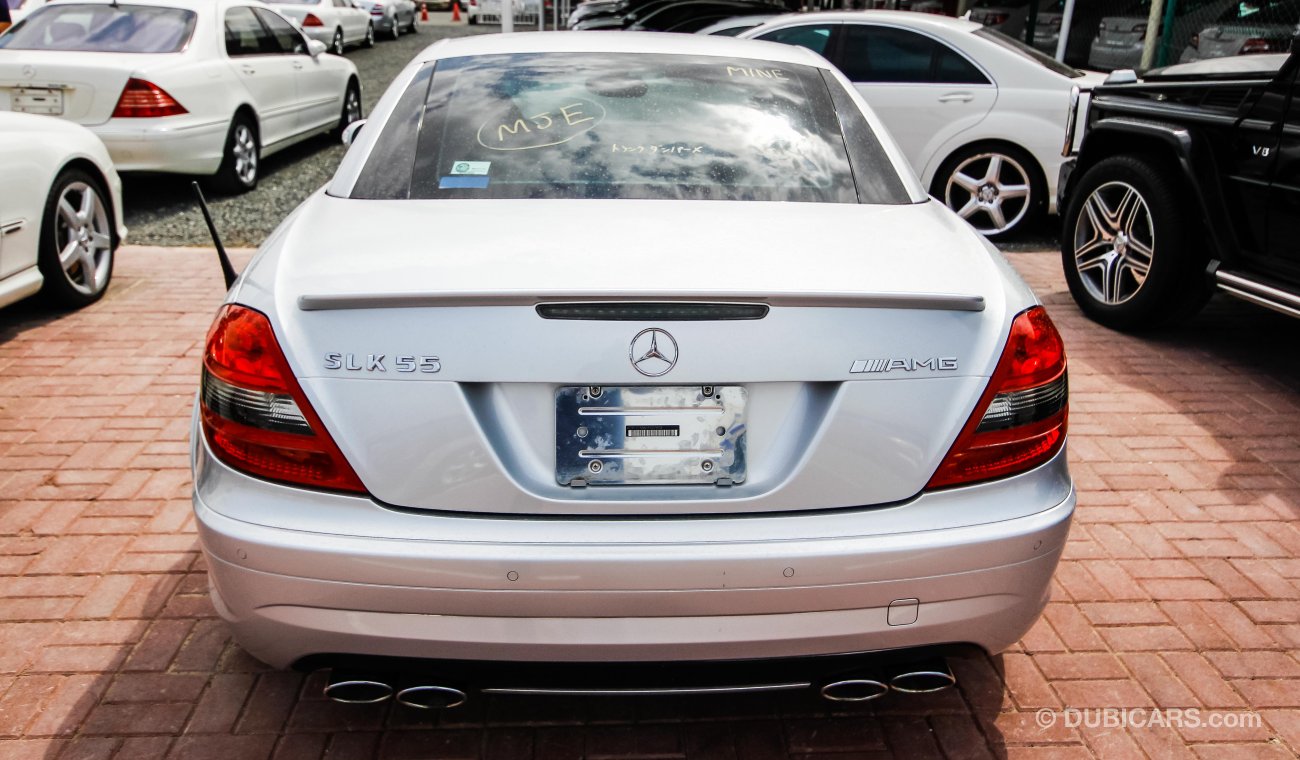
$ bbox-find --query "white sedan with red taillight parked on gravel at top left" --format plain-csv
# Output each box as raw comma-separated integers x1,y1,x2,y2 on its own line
0,0,361,192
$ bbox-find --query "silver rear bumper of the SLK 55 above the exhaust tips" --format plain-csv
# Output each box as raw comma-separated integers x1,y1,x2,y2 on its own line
194,436,1075,666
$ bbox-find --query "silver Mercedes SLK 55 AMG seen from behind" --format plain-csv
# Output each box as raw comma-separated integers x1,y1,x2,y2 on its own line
192,32,1075,707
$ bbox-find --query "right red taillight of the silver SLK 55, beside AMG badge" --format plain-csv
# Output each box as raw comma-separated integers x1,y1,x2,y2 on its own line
926,307,1069,488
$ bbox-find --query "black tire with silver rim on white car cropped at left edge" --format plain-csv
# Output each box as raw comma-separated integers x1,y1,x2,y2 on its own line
36,168,117,309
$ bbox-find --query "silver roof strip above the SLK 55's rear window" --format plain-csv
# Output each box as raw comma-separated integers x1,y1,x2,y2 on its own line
415,31,831,69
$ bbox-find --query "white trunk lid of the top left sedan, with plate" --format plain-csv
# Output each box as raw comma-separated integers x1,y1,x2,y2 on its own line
0,49,175,126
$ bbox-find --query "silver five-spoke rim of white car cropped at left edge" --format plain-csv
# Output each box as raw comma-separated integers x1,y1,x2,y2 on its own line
55,182,113,295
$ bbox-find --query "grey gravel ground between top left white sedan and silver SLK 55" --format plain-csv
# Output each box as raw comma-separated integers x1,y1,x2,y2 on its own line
122,22,495,247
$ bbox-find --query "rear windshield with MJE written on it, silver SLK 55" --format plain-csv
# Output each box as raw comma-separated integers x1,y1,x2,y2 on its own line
352,53,907,203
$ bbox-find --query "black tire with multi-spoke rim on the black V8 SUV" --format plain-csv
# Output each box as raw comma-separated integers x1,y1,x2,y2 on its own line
1061,155,1212,330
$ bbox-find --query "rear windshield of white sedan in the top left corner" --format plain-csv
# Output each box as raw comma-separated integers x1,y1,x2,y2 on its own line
0,3,198,53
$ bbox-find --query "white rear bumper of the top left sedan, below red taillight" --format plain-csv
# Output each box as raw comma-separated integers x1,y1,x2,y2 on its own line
90,117,230,175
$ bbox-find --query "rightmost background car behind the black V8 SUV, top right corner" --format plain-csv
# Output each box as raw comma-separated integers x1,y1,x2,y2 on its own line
1182,0,1300,61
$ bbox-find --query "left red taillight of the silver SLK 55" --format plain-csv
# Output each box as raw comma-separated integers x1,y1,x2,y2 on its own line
199,304,365,494
